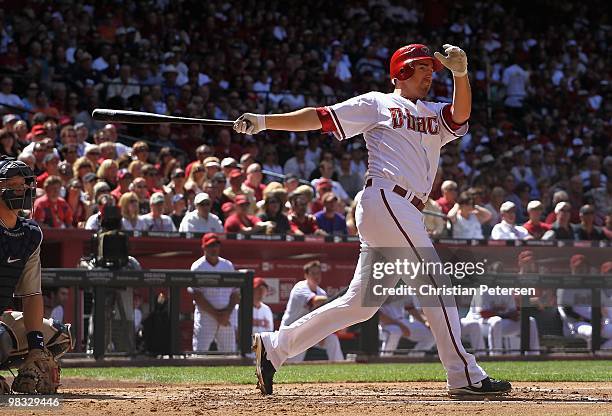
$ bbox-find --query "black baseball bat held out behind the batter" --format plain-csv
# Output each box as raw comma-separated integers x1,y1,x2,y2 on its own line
91,108,234,127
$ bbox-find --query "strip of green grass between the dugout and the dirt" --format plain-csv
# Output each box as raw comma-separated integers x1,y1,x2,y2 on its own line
62,360,612,384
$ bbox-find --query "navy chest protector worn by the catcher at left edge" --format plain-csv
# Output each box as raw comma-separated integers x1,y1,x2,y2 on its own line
0,218,42,312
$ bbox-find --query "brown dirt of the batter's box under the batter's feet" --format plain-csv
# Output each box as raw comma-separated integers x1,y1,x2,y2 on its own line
0,378,612,416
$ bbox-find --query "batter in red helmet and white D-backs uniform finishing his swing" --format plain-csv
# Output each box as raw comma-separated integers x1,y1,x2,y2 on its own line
234,44,511,396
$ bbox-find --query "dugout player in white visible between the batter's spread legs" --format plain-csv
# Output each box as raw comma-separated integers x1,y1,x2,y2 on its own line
378,295,436,356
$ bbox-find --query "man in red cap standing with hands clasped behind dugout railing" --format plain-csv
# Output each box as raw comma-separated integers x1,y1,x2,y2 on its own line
187,233,240,352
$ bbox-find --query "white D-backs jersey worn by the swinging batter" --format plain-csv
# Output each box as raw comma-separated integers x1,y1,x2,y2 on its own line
319,92,468,201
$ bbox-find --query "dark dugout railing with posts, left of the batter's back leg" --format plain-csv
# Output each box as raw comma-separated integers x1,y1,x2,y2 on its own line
42,269,254,359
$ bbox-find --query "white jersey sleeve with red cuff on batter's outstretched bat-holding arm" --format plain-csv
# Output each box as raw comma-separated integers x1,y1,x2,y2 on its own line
316,93,380,140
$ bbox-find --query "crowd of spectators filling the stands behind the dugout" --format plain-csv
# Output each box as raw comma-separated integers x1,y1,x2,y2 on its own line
0,0,612,240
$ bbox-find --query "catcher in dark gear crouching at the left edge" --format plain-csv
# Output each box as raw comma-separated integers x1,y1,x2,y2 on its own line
0,156,72,394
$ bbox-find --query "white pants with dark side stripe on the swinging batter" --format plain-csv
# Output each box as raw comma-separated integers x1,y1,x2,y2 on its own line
262,179,487,388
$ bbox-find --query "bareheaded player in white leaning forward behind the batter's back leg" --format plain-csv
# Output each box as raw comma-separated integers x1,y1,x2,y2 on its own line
281,260,344,362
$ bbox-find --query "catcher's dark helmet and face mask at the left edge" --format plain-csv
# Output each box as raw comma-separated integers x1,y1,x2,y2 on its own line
0,156,36,210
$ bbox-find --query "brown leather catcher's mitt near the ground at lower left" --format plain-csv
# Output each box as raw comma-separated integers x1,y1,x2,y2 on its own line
13,348,60,394
